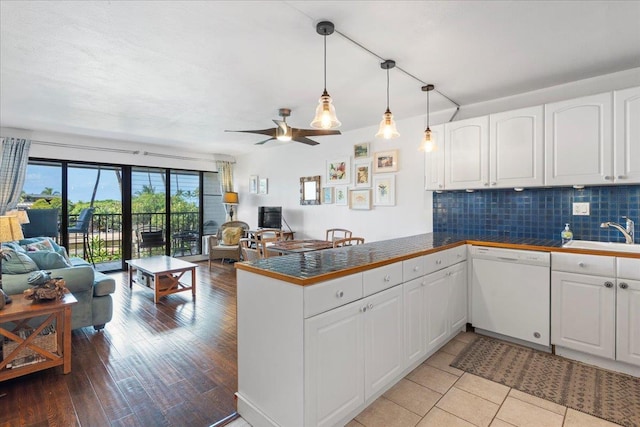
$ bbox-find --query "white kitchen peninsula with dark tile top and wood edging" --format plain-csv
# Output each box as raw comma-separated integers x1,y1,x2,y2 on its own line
236,233,640,426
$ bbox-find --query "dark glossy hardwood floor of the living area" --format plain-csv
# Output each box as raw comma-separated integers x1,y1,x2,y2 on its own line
0,262,237,427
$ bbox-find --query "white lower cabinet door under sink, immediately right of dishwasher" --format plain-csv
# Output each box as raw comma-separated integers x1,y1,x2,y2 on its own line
551,271,616,359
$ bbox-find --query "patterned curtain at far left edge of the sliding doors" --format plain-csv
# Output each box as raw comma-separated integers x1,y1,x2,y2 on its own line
0,138,31,215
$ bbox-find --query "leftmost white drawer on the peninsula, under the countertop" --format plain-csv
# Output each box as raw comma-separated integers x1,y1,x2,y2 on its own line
304,273,362,319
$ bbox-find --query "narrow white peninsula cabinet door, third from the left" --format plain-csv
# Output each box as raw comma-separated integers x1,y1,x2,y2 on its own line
402,277,427,366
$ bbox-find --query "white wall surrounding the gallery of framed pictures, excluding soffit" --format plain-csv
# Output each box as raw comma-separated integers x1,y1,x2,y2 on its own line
234,116,432,241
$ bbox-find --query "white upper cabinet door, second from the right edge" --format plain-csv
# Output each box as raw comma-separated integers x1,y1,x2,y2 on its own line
544,92,613,185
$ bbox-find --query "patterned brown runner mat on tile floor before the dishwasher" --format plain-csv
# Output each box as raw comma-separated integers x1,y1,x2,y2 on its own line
451,336,640,427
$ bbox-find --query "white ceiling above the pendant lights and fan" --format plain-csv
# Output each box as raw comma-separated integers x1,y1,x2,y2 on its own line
0,0,640,155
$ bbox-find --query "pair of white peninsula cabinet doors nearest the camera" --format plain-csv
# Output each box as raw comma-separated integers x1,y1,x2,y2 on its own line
305,286,404,426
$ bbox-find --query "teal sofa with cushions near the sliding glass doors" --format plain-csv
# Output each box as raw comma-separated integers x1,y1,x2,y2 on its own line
2,238,116,330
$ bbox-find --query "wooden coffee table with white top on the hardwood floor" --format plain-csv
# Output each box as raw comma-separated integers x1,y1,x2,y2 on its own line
126,255,198,304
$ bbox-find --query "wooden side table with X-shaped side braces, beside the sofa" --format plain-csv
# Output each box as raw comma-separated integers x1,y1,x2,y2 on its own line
0,293,78,381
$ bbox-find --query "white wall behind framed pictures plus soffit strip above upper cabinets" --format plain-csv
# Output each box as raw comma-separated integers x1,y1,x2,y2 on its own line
234,68,640,241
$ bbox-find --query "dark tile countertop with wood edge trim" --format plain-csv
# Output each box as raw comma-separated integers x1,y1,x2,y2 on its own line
235,233,640,285
